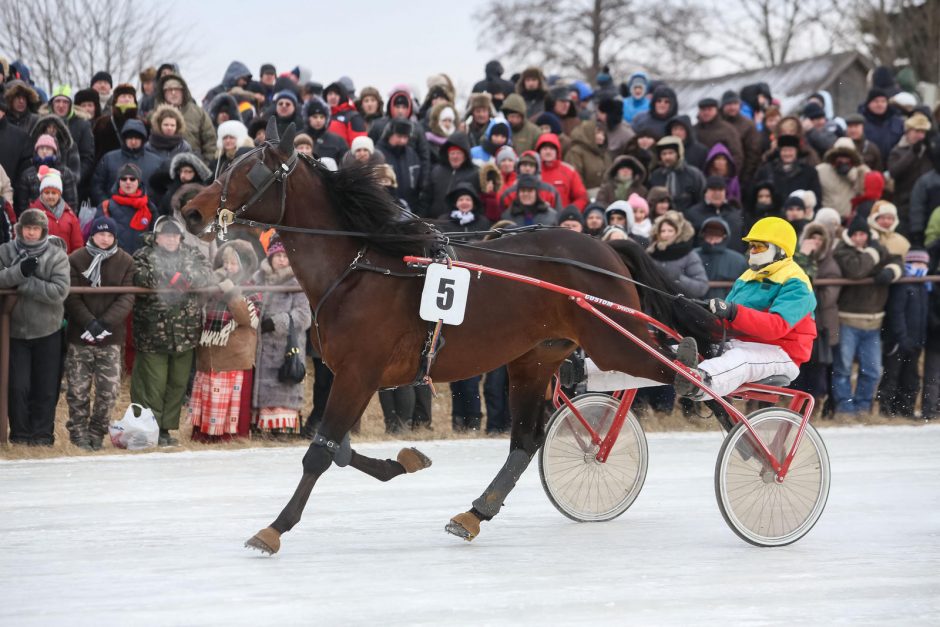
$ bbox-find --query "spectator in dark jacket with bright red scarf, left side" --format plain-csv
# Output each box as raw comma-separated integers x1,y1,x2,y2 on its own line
95,163,157,255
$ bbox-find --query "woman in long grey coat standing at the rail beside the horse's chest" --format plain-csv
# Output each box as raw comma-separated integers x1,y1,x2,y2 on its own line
253,236,311,432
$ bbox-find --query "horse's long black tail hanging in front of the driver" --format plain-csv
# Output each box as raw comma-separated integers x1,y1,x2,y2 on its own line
608,240,722,349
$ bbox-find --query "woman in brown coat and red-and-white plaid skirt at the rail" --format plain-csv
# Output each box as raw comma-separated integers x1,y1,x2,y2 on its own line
189,239,260,442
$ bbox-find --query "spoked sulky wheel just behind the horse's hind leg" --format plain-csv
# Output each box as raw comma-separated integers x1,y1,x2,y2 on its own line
539,394,649,522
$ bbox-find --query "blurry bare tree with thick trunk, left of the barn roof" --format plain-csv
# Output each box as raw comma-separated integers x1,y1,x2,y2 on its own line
475,0,704,81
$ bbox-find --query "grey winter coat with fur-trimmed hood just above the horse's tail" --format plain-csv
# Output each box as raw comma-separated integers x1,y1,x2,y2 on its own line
646,211,708,298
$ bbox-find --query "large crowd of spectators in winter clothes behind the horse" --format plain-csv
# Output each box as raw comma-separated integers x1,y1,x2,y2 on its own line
0,52,940,450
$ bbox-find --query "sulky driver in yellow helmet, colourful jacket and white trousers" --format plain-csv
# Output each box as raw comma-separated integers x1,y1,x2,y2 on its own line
675,218,816,400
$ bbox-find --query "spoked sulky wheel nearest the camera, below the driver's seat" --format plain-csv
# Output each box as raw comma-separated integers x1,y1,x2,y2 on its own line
715,407,830,546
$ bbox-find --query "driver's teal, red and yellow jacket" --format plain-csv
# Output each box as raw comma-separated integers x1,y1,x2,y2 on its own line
726,257,816,366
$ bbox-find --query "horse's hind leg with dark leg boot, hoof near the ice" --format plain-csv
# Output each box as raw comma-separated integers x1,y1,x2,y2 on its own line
444,340,575,542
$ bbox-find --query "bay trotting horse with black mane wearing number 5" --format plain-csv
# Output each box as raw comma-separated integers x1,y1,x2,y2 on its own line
182,125,718,554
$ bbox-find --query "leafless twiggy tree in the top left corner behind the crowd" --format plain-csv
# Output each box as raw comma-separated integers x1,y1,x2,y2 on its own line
0,0,189,90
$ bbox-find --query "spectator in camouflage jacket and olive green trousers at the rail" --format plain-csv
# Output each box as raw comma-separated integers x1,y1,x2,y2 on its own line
131,216,213,446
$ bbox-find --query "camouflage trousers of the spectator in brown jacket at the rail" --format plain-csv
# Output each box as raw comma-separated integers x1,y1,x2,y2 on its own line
65,343,121,442
